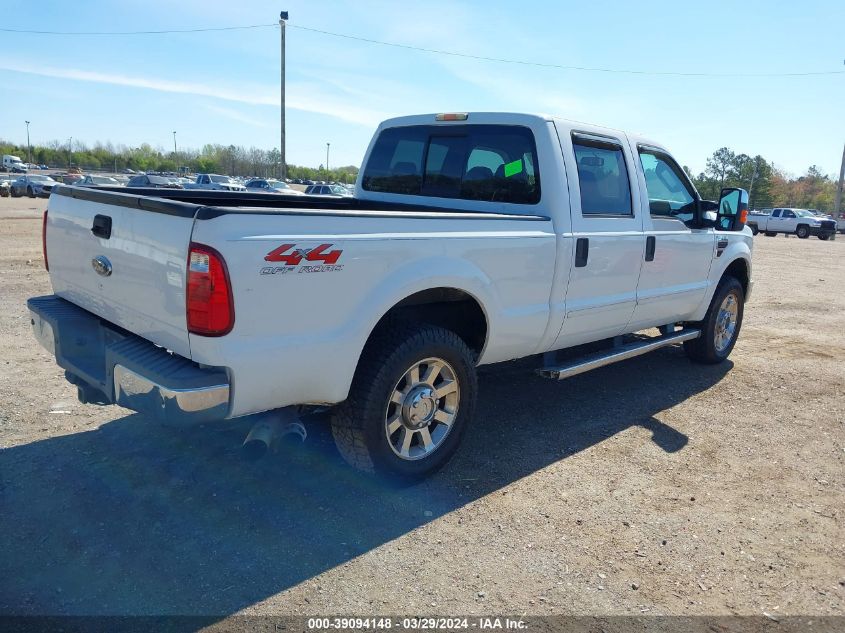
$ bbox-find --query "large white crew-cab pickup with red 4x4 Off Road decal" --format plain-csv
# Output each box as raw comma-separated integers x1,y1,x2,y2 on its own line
29,113,753,479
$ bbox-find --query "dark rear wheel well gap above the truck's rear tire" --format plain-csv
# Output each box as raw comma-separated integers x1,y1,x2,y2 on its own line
370,288,487,353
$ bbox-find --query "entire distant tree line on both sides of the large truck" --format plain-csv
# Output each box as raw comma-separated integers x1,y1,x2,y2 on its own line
0,140,836,212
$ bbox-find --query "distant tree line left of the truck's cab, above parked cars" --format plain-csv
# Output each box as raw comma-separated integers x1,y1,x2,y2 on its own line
0,140,358,183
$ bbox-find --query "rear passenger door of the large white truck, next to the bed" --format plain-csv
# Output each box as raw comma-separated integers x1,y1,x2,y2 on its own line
553,132,645,348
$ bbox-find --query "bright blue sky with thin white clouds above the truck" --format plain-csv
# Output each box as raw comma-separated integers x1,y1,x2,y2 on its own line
0,0,845,174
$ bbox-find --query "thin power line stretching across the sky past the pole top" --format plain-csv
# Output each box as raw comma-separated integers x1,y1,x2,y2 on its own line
0,22,845,78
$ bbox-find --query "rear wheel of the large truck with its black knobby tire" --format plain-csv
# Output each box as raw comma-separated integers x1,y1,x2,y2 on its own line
331,323,477,482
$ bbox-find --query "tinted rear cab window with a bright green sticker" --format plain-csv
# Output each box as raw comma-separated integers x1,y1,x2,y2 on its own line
361,124,540,205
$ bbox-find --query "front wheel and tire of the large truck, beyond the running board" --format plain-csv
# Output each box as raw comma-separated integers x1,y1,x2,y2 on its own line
684,277,745,365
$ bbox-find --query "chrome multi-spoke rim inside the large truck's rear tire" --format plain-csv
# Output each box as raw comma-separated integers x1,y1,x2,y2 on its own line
384,358,461,460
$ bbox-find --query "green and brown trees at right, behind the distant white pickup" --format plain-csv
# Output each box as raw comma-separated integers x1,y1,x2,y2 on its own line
684,147,837,212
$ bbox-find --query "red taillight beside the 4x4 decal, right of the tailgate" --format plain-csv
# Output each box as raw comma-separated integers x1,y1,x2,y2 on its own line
185,244,235,336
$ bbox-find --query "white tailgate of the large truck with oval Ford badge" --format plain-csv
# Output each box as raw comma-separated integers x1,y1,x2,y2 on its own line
46,190,193,358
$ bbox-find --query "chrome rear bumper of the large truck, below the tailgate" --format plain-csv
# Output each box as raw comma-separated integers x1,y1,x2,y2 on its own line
27,295,231,425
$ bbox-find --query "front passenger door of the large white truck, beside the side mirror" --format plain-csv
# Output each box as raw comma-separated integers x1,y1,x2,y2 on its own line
628,145,716,331
